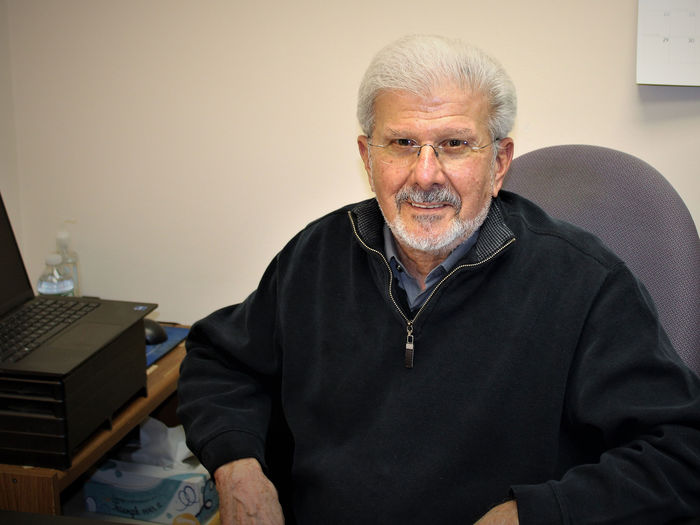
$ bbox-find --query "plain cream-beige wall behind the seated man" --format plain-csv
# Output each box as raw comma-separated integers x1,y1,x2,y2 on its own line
0,0,700,323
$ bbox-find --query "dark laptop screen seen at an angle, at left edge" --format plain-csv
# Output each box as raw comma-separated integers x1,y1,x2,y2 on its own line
0,195,34,315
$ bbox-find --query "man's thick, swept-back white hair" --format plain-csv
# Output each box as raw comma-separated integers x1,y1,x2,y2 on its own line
357,35,517,141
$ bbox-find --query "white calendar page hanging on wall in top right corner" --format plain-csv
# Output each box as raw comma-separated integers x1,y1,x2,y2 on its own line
637,0,700,86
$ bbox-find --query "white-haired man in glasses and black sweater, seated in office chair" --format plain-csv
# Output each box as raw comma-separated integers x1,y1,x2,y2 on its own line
179,37,700,524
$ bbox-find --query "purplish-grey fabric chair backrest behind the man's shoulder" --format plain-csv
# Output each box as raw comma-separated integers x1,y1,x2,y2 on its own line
504,145,700,375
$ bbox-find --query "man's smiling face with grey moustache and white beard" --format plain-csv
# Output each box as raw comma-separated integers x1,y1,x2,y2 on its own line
358,87,513,255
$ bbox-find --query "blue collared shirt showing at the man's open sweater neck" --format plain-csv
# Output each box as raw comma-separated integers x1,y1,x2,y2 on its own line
384,223,479,310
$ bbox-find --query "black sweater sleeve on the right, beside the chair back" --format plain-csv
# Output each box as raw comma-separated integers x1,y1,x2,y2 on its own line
511,266,700,525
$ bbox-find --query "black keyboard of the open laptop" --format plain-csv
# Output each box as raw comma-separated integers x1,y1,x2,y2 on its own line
0,298,100,363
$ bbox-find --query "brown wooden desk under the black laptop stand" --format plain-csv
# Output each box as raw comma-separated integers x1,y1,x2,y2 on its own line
0,343,185,514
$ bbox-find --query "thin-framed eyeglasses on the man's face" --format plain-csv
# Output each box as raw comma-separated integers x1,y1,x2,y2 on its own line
367,139,500,169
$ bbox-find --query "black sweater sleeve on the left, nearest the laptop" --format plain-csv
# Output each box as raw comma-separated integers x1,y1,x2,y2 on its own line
178,254,281,475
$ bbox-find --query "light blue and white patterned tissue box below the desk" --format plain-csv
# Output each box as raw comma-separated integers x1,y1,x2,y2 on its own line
83,460,219,525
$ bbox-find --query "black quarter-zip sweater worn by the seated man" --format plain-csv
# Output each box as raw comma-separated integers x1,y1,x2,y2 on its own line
179,192,700,525
